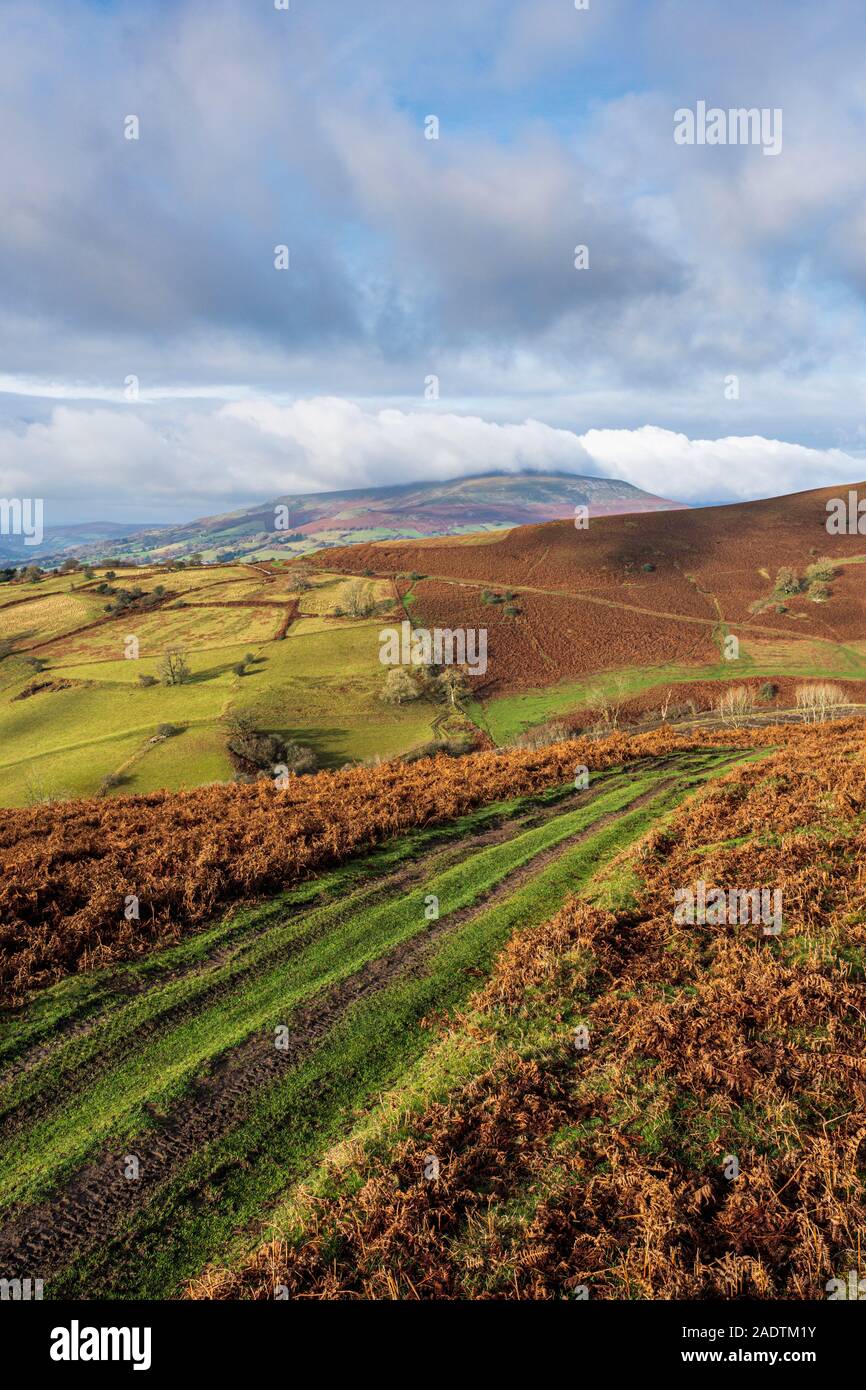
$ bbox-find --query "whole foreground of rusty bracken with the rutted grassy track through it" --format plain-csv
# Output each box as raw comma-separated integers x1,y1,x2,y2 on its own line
0,720,866,1298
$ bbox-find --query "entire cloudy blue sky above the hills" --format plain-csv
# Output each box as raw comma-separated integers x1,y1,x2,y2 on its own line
0,0,866,525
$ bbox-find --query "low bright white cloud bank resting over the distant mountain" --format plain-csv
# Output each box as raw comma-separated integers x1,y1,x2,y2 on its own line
0,396,866,524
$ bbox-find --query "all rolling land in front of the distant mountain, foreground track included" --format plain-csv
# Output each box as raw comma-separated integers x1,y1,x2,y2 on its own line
0,492,866,1300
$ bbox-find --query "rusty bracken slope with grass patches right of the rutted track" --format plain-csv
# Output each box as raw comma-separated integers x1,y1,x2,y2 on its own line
192,726,866,1300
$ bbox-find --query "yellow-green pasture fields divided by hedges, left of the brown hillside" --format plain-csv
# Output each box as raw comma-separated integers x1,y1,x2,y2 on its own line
0,566,439,806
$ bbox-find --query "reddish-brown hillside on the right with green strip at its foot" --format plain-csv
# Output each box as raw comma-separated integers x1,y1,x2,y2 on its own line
318,485,866,742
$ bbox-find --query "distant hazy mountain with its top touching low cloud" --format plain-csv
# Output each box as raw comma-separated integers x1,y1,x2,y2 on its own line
0,473,683,564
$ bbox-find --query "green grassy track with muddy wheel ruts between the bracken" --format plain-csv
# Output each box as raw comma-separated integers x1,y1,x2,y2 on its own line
0,752,761,1297
